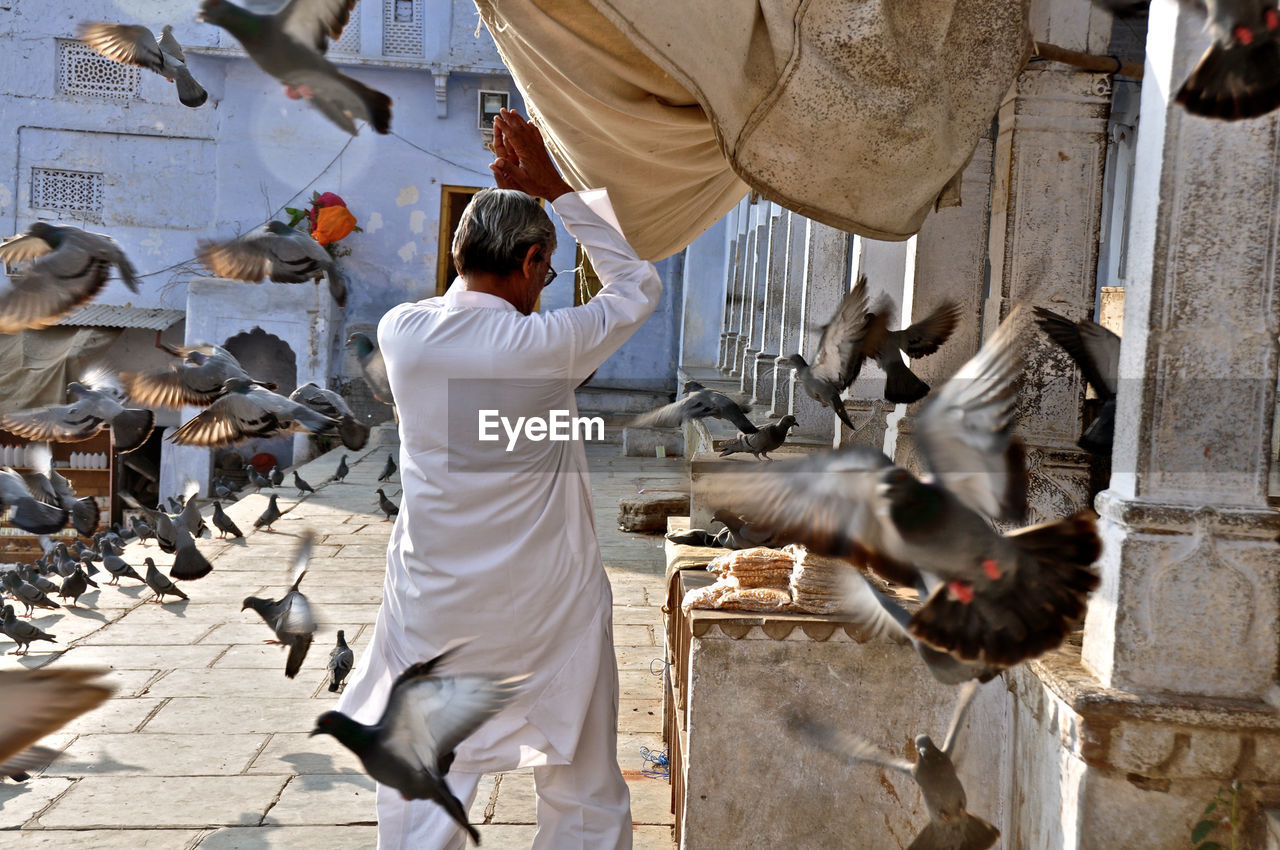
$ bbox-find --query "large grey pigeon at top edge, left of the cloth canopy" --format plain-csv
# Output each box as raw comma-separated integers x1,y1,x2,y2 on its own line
200,0,392,136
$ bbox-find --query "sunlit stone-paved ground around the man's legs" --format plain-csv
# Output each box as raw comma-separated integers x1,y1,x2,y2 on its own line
0,433,684,850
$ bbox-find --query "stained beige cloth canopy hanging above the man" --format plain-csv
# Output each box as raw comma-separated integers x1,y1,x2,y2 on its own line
476,0,1030,260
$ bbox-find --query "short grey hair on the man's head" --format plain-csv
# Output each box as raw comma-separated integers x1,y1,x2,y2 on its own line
452,189,556,275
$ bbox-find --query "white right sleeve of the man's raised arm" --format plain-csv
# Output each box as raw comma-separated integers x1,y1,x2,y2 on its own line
552,189,662,379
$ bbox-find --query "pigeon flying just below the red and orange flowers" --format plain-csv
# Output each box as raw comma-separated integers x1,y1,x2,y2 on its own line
196,221,347,307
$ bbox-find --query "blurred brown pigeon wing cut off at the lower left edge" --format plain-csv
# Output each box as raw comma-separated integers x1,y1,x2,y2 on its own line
0,670,115,781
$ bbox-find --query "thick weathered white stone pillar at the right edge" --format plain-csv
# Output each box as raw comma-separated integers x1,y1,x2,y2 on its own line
1084,3,1280,700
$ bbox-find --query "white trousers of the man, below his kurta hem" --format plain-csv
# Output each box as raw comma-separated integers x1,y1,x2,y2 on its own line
378,653,631,850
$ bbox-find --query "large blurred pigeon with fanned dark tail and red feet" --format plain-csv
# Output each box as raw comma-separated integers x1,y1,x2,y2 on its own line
707,311,1101,667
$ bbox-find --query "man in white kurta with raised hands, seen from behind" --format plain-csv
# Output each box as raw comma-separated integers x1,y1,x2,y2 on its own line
339,108,662,850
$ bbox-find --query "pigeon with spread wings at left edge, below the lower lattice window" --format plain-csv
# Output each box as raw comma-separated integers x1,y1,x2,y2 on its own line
0,221,138,334
